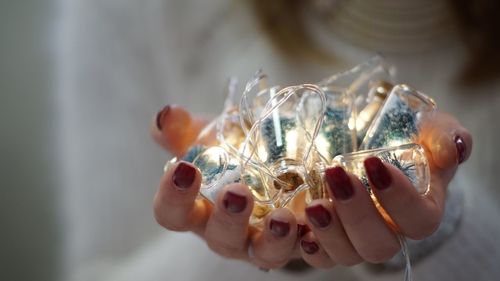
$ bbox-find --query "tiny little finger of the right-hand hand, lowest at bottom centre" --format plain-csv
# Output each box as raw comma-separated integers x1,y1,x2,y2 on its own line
300,232,335,268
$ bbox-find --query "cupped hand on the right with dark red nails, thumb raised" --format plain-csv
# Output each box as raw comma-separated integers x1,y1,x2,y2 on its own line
300,112,472,267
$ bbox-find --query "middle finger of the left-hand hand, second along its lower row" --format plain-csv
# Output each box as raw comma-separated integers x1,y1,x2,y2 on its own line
205,183,253,259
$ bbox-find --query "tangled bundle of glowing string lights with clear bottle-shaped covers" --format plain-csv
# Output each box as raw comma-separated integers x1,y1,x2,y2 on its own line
165,57,436,280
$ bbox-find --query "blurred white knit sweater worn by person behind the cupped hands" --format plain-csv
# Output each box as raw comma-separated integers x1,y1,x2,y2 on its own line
58,0,500,281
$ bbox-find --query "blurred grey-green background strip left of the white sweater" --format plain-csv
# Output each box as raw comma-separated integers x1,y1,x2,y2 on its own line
0,0,63,280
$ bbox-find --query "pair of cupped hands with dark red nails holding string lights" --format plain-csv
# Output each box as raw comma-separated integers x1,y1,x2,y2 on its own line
151,106,472,269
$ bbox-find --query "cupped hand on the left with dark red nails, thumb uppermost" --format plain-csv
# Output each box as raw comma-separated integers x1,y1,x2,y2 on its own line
151,106,299,269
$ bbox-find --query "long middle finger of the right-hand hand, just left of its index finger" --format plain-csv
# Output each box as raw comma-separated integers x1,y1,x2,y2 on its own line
325,167,400,263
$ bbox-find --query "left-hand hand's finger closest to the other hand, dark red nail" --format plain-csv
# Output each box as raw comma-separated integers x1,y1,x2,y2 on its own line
252,208,297,269
